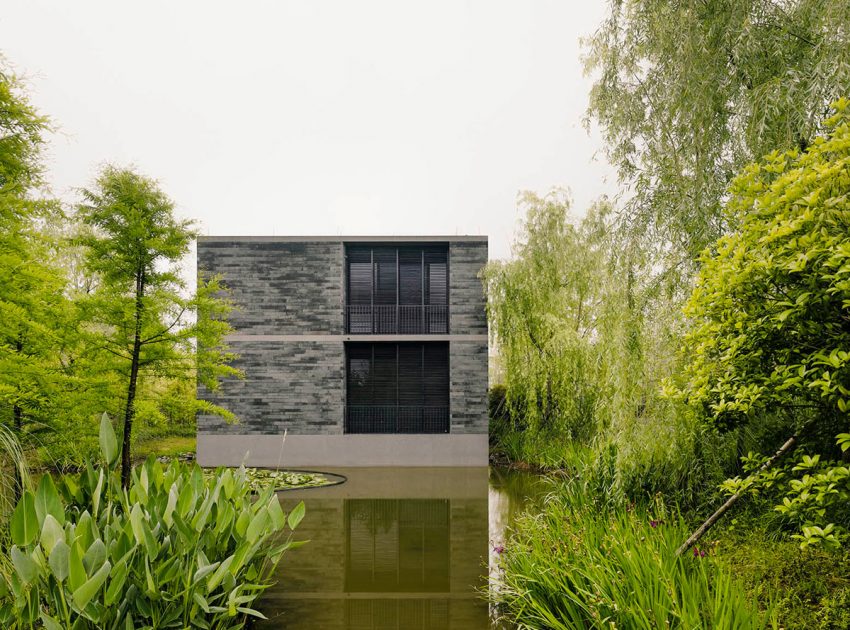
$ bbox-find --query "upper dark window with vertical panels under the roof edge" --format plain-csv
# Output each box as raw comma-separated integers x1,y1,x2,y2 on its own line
345,245,449,334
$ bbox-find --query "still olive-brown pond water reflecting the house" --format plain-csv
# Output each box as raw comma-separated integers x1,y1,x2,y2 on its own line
259,468,546,630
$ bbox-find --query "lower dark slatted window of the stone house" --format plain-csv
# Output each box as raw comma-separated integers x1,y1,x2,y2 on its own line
345,342,449,433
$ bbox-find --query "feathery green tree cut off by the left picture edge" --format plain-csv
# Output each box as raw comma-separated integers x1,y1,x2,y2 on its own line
0,65,67,498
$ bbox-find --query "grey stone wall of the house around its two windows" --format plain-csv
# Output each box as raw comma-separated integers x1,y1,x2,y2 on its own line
198,237,488,465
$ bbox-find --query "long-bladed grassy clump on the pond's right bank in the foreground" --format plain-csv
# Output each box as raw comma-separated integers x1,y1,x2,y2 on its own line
492,481,766,630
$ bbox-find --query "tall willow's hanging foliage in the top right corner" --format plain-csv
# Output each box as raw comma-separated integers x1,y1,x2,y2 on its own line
585,0,850,270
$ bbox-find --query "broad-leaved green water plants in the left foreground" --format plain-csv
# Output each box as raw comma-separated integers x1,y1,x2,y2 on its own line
0,415,304,630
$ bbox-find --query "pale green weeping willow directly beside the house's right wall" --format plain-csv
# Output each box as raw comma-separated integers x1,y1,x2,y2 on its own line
484,191,622,441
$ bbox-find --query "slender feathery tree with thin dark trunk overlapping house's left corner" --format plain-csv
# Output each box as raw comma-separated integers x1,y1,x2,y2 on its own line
78,166,237,486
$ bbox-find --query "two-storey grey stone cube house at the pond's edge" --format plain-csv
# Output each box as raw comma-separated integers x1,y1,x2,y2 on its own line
198,236,488,467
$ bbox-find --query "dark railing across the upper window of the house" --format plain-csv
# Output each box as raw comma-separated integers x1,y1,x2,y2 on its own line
345,304,449,335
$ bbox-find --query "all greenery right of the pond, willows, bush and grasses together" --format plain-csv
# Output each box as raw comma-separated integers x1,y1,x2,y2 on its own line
484,0,850,629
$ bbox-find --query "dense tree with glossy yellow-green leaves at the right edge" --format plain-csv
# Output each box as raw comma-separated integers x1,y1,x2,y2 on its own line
680,99,850,545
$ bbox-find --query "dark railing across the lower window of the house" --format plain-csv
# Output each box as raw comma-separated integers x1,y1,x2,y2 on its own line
345,405,449,433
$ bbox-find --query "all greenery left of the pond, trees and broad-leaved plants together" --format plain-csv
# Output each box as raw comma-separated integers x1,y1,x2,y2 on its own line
0,58,304,630
